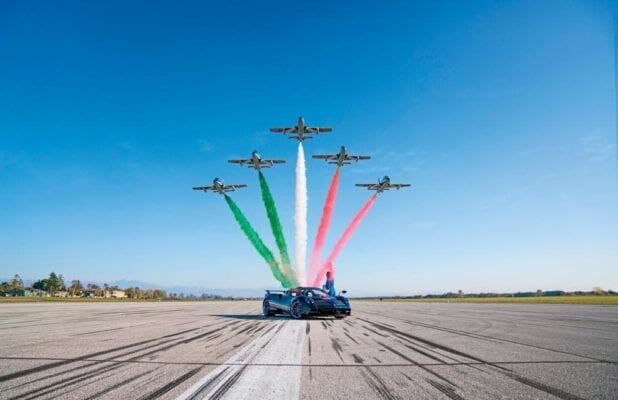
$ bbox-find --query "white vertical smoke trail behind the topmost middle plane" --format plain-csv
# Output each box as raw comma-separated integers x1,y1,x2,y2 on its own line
294,142,307,286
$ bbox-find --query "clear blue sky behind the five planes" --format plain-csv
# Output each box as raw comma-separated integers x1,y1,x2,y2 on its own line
0,1,618,293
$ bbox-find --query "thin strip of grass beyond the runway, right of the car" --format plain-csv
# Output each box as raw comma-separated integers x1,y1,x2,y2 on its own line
358,296,618,305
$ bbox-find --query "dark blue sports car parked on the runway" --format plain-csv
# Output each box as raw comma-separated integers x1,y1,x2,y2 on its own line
262,287,352,319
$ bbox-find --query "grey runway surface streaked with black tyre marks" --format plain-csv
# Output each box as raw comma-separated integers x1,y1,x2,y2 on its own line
0,301,618,400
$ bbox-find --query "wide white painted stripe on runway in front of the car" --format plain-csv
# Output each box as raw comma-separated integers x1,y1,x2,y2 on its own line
178,320,305,400
